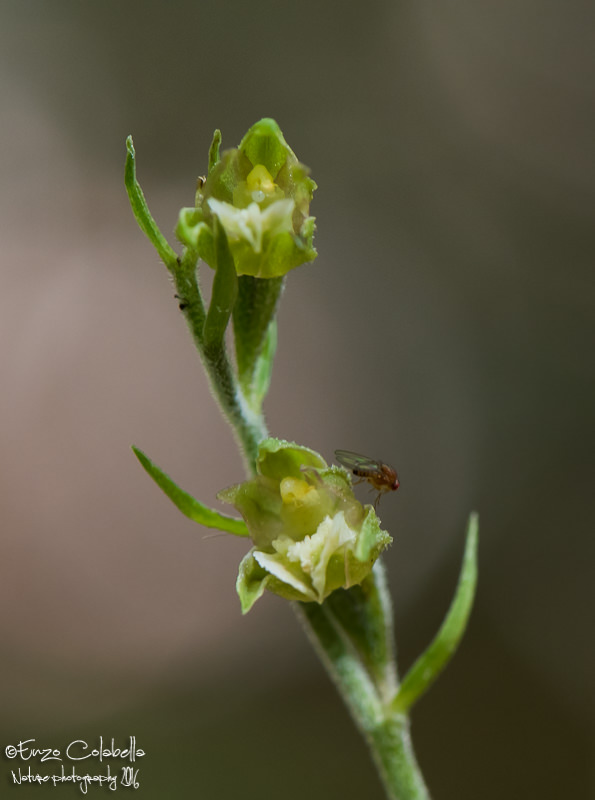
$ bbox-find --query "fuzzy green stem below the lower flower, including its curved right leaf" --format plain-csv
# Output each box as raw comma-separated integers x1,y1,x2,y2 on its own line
298,513,479,800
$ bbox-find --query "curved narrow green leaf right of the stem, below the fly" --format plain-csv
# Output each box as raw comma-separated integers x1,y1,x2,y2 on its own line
391,513,479,714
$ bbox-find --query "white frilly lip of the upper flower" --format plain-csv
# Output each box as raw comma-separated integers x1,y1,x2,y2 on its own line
207,197,295,253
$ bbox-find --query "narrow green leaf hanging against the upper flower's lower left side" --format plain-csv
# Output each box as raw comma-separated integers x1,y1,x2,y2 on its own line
203,219,238,350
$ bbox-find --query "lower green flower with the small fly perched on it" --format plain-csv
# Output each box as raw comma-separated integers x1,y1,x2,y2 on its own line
218,439,392,612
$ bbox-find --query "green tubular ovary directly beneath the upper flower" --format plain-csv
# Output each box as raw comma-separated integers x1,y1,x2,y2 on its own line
233,275,283,400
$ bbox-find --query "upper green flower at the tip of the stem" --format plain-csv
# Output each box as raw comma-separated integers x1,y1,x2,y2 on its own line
176,119,316,278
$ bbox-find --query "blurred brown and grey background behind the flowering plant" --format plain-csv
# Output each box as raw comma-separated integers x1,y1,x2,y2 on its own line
0,0,595,800
